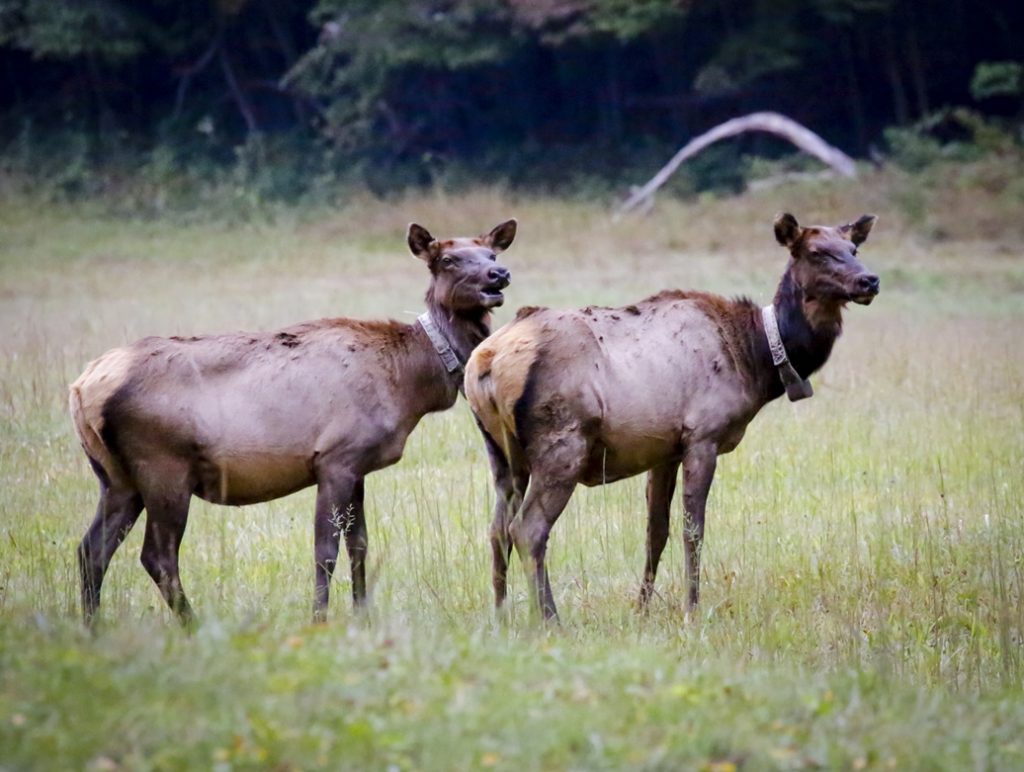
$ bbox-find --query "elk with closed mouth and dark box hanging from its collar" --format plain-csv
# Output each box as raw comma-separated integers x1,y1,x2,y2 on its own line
465,214,879,618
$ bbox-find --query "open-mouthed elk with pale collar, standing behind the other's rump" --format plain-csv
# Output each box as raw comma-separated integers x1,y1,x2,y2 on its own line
70,219,516,625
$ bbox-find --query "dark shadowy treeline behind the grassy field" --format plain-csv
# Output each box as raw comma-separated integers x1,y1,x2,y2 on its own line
0,0,1024,204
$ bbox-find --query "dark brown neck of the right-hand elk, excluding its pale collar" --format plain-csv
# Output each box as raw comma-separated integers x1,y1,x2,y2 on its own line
753,268,843,401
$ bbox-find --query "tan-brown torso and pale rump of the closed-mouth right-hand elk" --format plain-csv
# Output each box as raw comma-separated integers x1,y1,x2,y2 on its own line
466,293,761,485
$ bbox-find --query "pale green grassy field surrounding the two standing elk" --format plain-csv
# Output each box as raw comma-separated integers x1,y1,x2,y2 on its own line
0,170,1024,772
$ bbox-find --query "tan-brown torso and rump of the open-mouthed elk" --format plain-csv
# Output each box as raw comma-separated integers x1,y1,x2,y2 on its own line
71,318,458,505
